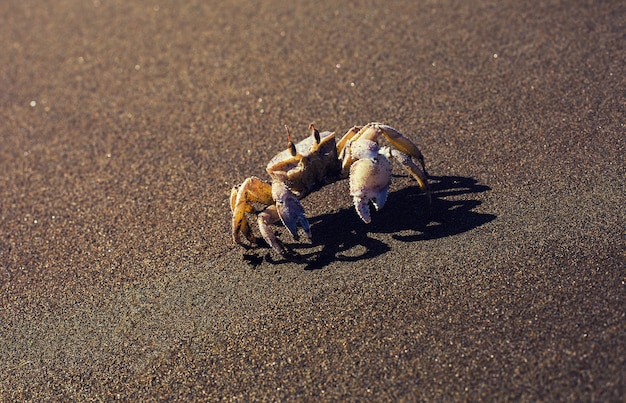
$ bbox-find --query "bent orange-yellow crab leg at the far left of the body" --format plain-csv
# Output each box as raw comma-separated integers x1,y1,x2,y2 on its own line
230,176,274,244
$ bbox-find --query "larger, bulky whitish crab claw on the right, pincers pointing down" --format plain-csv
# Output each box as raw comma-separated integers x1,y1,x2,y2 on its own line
350,153,391,224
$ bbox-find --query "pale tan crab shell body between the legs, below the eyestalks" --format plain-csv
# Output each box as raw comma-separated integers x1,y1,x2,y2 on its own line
266,132,341,198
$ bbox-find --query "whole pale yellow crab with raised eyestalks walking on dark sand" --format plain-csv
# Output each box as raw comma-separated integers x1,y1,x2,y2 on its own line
230,122,430,256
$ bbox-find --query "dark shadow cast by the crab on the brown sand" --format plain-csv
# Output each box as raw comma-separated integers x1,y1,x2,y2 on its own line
247,176,496,270
